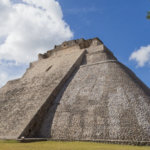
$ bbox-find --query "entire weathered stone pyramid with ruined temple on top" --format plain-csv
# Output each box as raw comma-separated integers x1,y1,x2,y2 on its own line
0,38,150,145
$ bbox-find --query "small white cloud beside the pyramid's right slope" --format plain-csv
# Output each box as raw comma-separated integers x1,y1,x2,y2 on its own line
129,45,150,67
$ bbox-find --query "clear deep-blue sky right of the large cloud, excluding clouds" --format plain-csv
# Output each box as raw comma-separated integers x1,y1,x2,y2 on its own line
59,0,150,87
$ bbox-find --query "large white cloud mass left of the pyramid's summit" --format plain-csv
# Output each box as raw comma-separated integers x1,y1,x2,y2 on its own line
0,0,73,87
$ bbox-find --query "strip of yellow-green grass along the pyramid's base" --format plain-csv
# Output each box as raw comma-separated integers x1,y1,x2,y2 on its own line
0,140,150,150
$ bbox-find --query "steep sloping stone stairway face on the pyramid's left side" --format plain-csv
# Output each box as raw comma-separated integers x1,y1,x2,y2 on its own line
0,48,84,139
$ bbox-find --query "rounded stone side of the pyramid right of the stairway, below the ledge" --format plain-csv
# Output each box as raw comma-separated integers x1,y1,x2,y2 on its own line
39,60,150,141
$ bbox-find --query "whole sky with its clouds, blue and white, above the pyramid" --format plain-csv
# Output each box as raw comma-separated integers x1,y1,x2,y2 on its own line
0,0,150,87
